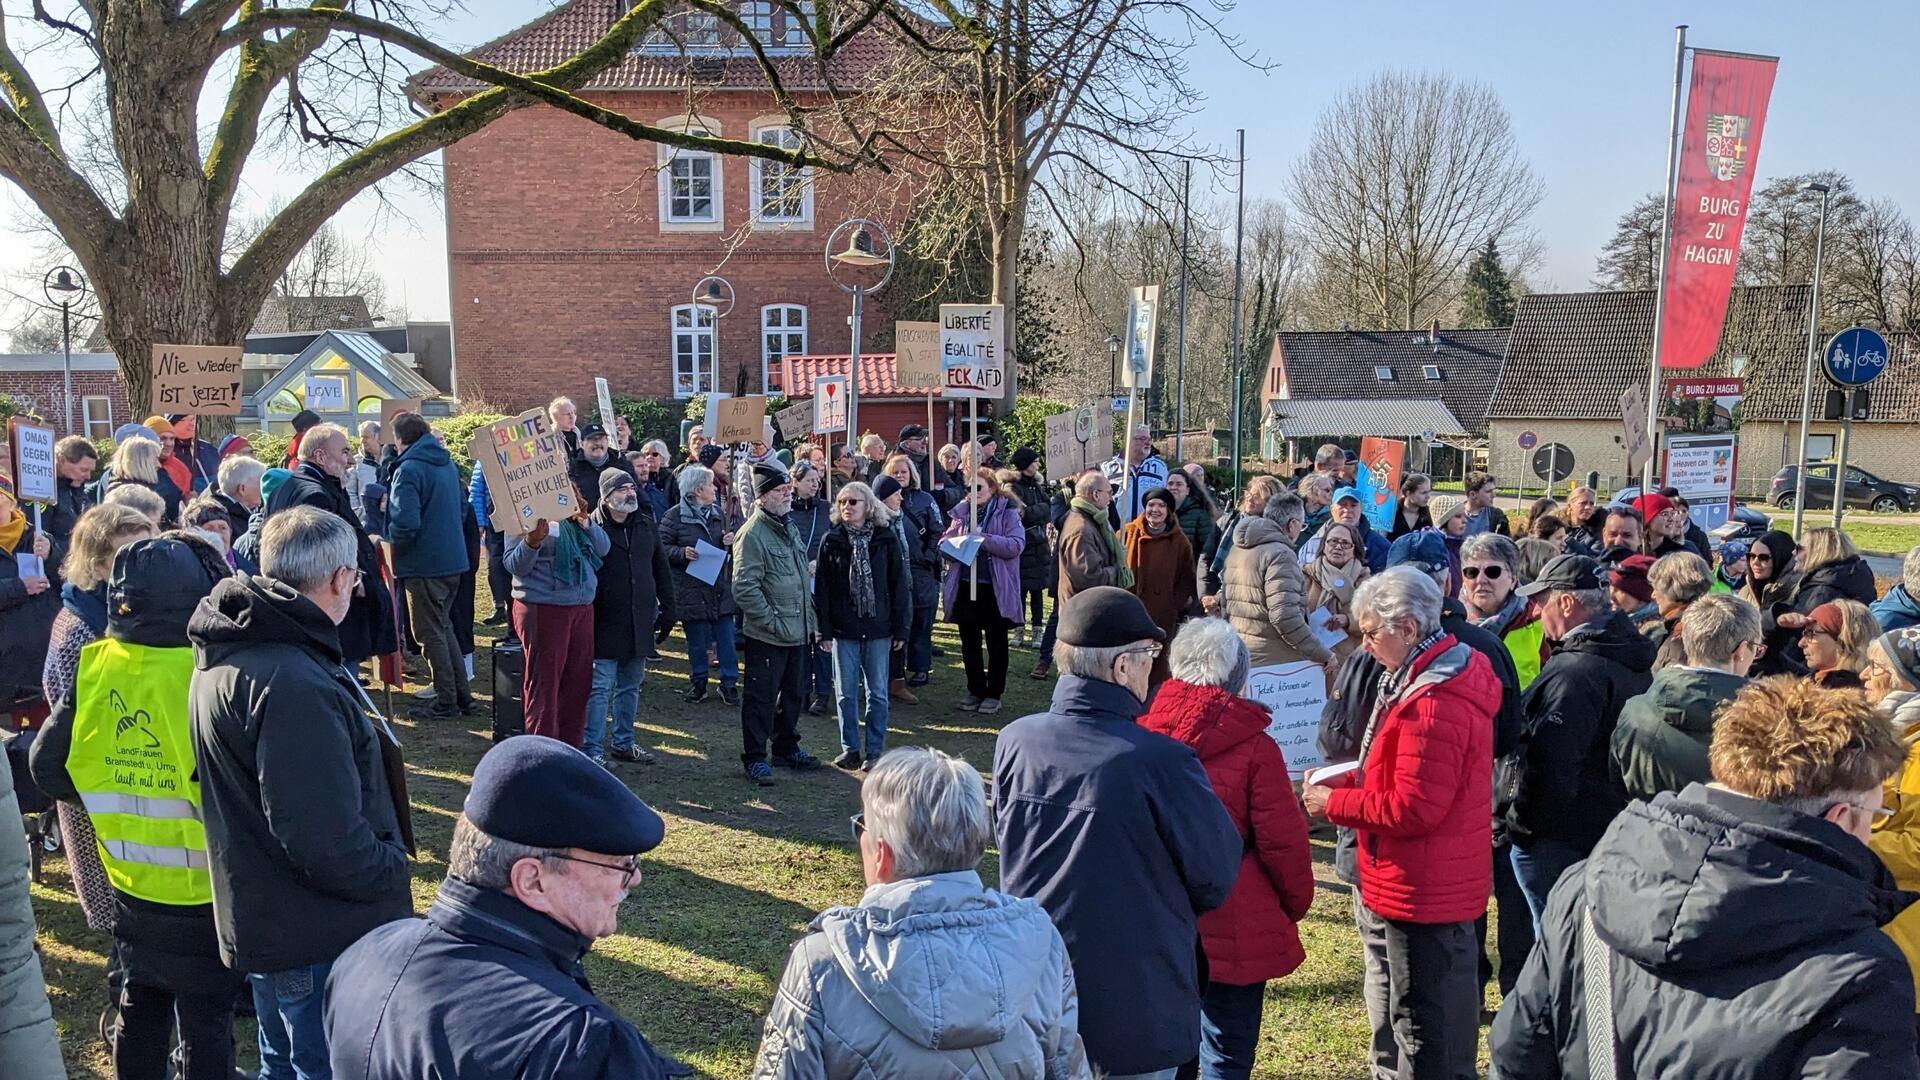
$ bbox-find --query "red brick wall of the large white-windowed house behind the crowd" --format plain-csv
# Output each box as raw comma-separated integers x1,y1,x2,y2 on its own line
445,92,899,409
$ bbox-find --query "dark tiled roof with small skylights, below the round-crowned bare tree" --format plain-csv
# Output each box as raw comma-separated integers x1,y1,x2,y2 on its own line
1273,329,1507,434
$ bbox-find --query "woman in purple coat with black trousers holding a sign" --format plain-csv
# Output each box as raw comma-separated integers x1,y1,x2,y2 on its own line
941,469,1027,713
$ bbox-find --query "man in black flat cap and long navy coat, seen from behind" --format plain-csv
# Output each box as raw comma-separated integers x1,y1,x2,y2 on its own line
993,586,1242,1080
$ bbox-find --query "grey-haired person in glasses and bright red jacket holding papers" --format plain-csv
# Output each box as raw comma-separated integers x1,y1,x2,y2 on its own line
1300,567,1500,1080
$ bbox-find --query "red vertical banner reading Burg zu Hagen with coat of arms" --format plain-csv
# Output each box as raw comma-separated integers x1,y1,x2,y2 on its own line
1661,48,1780,367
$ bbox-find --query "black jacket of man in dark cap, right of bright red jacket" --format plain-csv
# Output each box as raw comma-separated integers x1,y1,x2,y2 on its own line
1494,611,1657,849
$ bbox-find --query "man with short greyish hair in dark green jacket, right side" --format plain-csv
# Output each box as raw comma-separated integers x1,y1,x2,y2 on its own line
1613,592,1766,799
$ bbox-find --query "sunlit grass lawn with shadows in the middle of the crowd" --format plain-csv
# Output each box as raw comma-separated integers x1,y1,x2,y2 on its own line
22,586,1484,1080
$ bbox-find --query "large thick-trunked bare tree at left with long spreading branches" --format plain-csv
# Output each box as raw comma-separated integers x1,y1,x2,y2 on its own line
0,0,893,411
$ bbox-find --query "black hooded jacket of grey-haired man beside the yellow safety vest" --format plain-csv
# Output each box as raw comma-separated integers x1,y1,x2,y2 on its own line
186,577,413,974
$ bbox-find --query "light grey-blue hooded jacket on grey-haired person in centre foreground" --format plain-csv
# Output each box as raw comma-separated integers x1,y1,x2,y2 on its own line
753,871,1092,1080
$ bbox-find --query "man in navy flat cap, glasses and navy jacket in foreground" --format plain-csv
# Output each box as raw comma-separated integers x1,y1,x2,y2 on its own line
326,734,684,1080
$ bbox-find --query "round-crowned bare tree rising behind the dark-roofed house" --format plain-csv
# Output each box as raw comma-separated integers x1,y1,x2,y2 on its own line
1290,71,1542,329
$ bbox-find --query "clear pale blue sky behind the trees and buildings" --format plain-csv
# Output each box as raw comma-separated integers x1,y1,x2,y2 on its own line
15,0,1920,317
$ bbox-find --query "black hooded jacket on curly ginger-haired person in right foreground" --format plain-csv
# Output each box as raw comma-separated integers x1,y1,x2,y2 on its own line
1488,784,1920,1080
